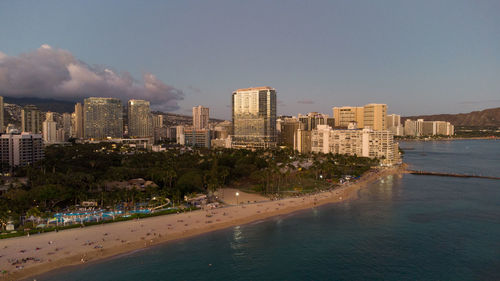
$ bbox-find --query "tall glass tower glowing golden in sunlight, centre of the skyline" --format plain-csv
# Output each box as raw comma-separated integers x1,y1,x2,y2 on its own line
232,87,277,148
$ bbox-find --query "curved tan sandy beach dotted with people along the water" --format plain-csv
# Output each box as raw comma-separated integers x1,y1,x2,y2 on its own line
0,167,404,280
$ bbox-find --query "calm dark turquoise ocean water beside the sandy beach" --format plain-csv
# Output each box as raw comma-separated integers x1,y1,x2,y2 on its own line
37,140,500,281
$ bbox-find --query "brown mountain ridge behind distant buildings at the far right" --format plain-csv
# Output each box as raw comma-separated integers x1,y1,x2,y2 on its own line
402,107,500,127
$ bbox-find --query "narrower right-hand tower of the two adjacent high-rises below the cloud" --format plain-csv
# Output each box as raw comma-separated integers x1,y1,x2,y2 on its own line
128,100,153,138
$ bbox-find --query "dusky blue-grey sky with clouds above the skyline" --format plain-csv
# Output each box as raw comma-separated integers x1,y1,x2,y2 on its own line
0,0,500,119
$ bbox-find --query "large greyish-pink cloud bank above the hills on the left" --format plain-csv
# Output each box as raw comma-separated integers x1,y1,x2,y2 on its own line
0,45,184,111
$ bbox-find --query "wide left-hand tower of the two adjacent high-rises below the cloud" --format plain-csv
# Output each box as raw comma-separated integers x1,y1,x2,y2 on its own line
83,97,123,139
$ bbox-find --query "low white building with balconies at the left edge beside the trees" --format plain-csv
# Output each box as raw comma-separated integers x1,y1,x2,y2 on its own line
0,132,44,166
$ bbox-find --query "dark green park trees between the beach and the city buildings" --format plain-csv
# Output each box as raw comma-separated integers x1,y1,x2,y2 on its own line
0,143,378,229
